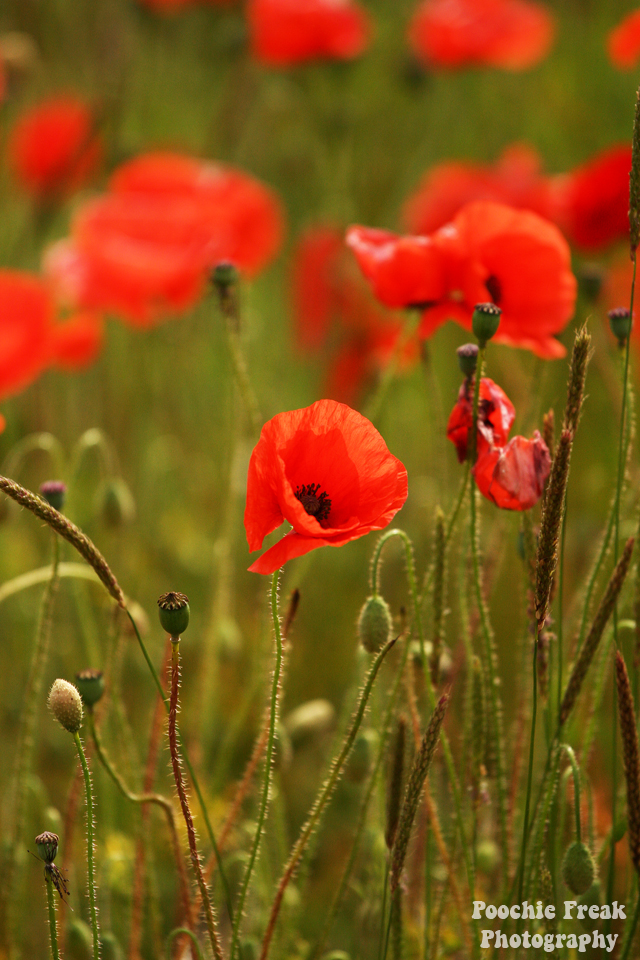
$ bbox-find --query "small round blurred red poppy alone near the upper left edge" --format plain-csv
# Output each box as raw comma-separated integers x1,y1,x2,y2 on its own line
8,97,102,198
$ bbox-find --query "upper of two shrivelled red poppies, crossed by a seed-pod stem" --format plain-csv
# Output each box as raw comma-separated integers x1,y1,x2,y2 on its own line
447,377,516,463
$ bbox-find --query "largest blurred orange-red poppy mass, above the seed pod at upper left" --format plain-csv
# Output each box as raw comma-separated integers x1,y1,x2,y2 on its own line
45,153,283,326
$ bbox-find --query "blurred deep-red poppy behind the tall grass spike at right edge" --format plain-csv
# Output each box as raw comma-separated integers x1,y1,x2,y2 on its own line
554,144,631,251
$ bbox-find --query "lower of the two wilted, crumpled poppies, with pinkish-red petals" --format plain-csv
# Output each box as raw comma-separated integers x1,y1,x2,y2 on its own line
473,430,551,510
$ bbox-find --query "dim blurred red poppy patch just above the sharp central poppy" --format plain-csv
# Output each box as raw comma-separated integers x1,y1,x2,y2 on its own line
292,226,418,405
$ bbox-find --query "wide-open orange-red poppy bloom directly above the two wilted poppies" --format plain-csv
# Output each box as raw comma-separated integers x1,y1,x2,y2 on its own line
347,201,576,357
